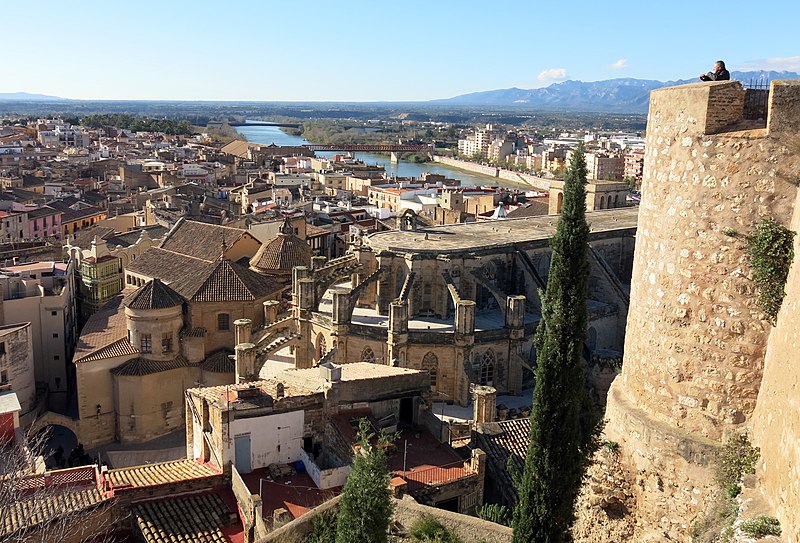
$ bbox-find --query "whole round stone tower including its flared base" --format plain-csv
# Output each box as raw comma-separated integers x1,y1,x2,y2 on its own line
606,81,800,541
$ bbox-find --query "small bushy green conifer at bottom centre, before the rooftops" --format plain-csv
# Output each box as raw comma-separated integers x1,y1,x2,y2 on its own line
336,419,392,543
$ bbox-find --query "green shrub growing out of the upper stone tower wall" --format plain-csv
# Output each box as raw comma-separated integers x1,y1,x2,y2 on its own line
747,219,795,325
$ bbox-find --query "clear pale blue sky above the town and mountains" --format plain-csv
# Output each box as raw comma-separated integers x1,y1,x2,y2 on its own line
6,0,800,102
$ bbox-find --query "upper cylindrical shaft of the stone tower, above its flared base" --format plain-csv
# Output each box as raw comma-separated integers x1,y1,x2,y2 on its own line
622,81,799,440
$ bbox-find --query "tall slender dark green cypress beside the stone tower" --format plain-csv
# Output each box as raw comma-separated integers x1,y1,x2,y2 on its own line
512,142,598,543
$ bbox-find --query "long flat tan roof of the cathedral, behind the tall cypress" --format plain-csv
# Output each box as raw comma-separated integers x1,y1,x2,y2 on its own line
367,207,639,254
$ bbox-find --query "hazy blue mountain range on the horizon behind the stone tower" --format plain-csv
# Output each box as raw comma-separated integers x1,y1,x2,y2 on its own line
430,70,800,113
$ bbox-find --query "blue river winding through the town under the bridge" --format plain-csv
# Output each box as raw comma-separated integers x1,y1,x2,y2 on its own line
236,126,530,189
